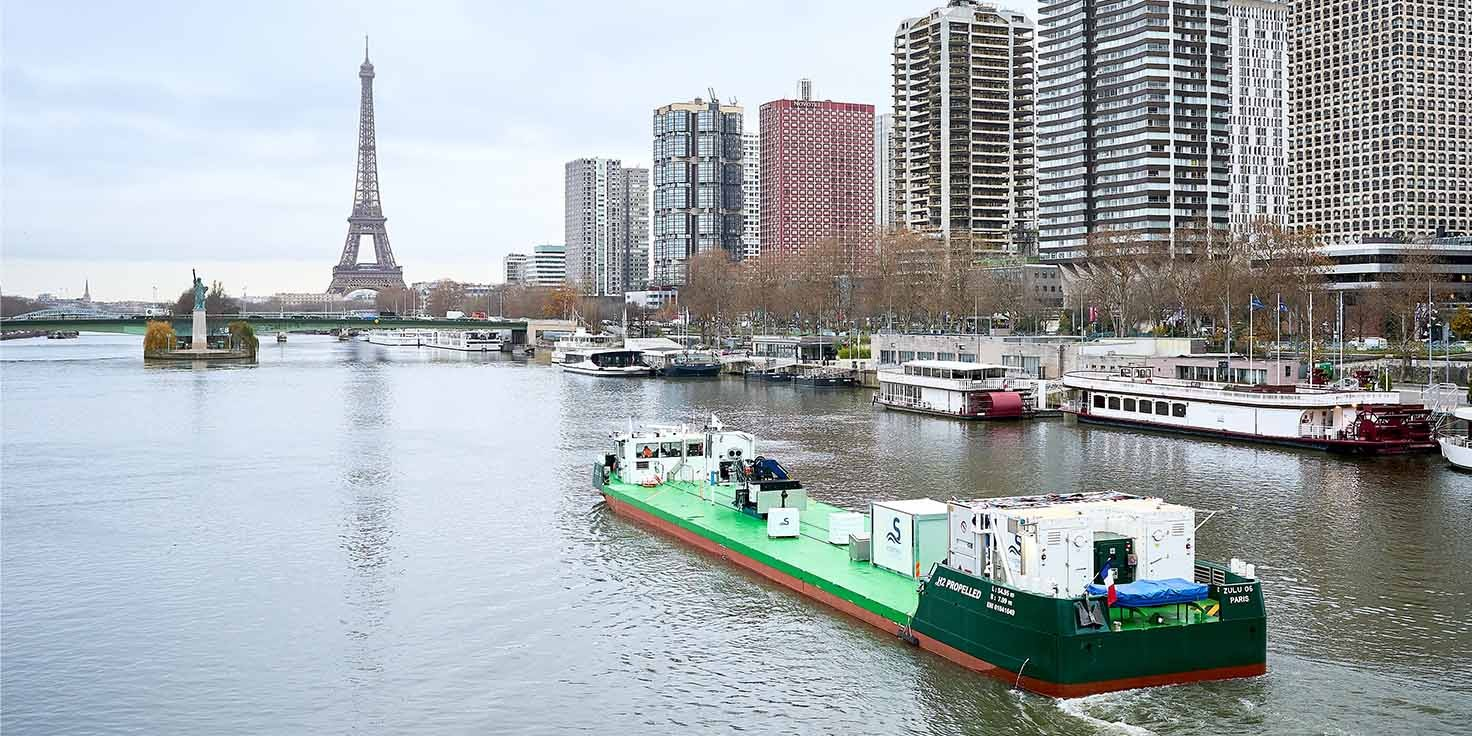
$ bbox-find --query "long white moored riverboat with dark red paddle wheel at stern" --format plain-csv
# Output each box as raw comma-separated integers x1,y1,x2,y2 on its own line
1063,368,1437,453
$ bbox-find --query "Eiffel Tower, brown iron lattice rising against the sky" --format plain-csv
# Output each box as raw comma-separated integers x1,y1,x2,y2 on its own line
327,37,405,294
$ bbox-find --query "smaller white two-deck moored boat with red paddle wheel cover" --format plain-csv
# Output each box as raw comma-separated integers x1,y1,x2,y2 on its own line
874,361,1036,420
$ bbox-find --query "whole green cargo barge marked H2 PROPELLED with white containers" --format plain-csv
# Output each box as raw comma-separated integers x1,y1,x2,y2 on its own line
593,417,1267,698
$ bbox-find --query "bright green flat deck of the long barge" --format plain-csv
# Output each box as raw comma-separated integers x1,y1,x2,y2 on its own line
604,475,919,624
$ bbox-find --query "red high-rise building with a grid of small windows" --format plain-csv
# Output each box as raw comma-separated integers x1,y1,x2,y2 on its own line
760,89,874,268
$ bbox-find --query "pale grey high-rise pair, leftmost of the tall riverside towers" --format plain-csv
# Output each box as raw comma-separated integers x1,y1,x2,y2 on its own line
564,158,649,296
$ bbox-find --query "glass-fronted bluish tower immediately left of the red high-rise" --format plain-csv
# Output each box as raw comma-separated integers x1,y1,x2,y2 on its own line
651,97,746,286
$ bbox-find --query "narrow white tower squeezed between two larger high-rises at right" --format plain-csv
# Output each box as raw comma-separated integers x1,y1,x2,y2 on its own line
1228,0,1288,231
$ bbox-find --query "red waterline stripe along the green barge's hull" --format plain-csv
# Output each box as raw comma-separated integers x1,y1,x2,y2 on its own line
604,495,1267,698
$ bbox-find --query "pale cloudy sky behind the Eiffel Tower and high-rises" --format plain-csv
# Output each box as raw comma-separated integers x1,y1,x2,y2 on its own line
0,0,1035,299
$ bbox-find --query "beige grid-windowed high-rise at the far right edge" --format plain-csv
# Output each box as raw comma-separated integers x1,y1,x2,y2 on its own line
1288,0,1472,246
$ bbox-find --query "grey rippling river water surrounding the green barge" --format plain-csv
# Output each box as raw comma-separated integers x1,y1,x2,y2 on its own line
0,334,1472,736
